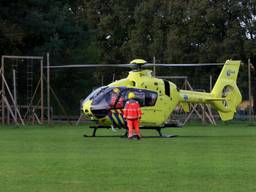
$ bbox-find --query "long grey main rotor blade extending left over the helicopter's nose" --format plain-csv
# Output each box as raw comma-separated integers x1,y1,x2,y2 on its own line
44,64,133,69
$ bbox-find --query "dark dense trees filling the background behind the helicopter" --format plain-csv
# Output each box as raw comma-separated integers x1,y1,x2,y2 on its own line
0,0,256,113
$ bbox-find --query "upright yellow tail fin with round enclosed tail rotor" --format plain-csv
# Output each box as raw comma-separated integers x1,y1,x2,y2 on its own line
211,60,242,121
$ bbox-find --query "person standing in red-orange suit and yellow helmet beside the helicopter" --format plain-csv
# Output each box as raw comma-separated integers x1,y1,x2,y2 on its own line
123,92,142,139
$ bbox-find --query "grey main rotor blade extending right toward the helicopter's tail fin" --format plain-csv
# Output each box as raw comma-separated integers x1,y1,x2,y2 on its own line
143,63,224,67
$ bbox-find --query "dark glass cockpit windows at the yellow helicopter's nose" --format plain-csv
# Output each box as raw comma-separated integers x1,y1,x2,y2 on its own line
84,87,158,118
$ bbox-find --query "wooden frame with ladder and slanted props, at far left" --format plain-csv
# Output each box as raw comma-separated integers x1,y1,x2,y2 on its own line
0,55,44,125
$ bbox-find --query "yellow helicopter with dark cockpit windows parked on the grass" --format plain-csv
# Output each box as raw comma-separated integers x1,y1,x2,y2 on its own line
49,59,242,136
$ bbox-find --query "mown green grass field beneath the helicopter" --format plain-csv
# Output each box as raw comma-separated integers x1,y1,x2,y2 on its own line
0,123,256,192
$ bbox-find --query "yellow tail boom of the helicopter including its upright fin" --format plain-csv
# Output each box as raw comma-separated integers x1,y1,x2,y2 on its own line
180,60,242,121
